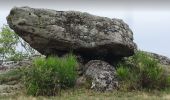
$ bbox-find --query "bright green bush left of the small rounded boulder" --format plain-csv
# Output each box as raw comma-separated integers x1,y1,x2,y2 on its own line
24,54,78,96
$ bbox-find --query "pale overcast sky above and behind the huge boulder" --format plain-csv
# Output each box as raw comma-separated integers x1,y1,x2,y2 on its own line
0,0,170,57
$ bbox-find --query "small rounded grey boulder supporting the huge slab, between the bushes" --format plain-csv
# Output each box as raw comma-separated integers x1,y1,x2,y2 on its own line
85,60,118,91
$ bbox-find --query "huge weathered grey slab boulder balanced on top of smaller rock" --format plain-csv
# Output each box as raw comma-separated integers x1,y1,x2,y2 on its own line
7,7,136,58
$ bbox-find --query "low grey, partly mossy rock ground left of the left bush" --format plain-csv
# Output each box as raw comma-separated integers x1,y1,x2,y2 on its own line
0,55,40,96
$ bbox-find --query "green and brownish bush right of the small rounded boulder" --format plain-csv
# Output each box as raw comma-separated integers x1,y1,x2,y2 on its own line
117,51,170,90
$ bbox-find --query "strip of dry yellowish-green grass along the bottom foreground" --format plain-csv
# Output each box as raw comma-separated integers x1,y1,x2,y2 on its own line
0,89,170,100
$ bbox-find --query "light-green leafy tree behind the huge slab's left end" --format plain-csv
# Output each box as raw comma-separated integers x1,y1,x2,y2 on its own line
0,25,37,61
